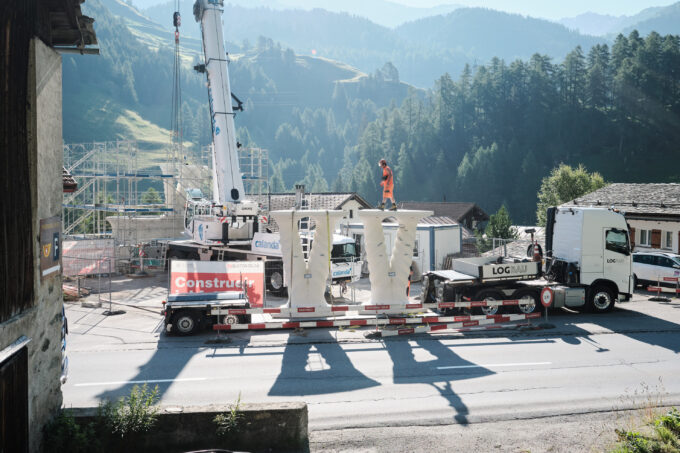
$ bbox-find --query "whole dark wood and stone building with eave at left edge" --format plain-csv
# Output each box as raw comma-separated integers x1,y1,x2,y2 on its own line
0,0,96,452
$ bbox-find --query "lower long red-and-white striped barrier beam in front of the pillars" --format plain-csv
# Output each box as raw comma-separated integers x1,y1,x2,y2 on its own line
213,313,541,330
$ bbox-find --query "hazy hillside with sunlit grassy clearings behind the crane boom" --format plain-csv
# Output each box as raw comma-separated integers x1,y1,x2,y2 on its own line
63,0,412,171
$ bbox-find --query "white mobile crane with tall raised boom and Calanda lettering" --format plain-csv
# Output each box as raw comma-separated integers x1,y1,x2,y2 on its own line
165,0,361,293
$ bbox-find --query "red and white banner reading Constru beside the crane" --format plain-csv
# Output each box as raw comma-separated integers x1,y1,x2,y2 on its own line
170,260,264,307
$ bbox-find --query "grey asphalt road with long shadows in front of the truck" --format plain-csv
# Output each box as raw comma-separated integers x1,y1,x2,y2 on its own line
63,279,680,430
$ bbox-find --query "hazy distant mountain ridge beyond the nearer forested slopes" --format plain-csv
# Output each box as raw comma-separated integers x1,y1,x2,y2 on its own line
145,0,604,88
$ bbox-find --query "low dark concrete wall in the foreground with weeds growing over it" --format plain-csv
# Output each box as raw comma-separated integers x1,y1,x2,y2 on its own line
66,402,308,453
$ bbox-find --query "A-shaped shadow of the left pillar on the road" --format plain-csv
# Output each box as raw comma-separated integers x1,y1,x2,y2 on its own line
268,331,380,396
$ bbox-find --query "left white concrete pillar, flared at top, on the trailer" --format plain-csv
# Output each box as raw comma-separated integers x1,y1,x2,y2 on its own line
271,210,343,316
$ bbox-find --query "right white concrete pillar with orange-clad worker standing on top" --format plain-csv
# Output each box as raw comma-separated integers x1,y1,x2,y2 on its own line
359,209,432,305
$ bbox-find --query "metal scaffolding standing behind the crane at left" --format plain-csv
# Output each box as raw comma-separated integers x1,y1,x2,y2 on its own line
62,140,269,246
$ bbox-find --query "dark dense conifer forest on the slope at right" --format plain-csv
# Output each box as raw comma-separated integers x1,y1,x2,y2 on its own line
341,32,680,223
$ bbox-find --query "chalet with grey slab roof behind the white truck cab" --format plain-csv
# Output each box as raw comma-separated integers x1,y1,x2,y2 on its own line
564,183,680,253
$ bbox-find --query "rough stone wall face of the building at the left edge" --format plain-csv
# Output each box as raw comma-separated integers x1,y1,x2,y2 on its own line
0,38,63,452
